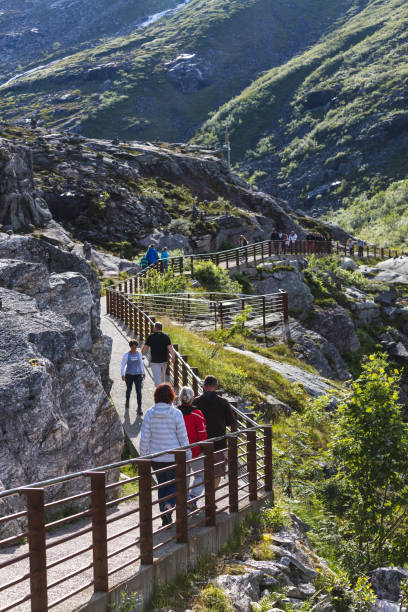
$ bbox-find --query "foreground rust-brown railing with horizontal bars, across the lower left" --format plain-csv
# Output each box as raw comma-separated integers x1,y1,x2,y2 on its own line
0,424,272,612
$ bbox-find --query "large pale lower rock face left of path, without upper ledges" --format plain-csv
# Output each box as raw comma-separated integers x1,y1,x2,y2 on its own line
0,288,123,532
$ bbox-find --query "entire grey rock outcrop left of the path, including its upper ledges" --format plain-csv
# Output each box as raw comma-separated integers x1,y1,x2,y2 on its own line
0,233,123,532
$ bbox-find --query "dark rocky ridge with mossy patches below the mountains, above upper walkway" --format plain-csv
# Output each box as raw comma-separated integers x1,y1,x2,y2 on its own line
0,125,318,257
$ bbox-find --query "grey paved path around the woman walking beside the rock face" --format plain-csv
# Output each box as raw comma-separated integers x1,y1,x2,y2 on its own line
101,298,154,451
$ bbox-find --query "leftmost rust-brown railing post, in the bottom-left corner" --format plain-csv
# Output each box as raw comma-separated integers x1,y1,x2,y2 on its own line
21,487,48,612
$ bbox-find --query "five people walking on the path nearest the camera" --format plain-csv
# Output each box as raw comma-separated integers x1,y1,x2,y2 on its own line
121,322,236,526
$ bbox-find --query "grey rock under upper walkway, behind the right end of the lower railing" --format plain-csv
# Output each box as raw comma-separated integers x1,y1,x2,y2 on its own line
254,270,313,319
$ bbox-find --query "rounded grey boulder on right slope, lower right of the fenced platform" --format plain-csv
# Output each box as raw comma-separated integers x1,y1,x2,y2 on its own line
310,306,360,353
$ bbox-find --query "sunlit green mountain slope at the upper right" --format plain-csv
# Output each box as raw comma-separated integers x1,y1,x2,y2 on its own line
196,0,408,210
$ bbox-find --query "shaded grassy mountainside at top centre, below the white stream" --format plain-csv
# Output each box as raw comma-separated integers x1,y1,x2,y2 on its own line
0,0,358,140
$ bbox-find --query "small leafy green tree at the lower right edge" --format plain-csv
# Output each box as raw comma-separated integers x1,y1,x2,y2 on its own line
329,354,408,566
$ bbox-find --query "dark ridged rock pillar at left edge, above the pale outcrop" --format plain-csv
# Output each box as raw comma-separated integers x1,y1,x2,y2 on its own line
0,138,51,230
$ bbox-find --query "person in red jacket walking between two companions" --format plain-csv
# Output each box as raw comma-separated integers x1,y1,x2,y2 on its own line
178,387,207,510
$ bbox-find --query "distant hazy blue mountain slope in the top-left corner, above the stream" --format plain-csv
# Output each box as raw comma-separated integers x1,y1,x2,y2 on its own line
0,0,180,80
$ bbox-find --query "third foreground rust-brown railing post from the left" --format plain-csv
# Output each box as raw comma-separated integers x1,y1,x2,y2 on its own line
135,459,153,565
